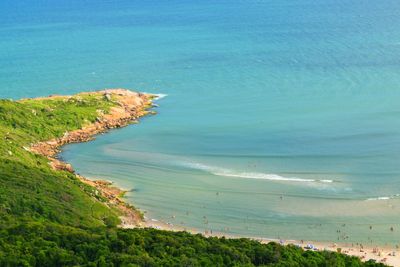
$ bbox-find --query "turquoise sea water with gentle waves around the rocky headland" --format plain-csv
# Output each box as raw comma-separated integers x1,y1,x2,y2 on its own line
0,0,400,244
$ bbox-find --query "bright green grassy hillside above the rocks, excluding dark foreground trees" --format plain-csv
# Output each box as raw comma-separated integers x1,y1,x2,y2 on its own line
0,96,118,230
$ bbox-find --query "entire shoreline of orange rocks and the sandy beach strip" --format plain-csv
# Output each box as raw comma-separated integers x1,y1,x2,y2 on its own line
27,89,400,266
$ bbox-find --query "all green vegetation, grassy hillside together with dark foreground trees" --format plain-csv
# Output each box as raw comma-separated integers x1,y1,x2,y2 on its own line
0,95,383,266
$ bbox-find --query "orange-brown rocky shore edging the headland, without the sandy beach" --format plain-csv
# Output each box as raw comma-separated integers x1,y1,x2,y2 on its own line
28,89,156,227
